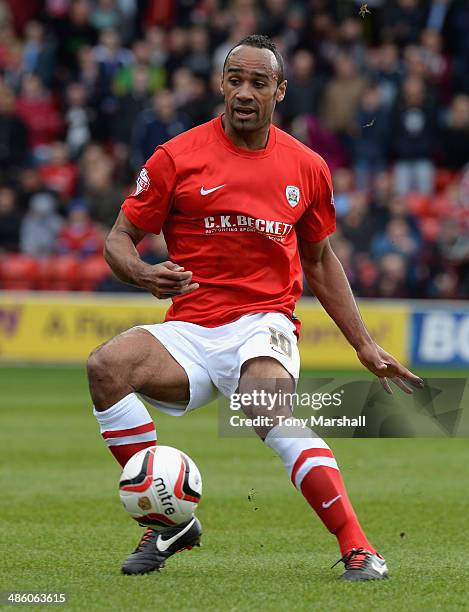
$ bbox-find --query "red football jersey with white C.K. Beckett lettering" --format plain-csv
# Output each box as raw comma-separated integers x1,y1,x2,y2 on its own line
122,117,335,334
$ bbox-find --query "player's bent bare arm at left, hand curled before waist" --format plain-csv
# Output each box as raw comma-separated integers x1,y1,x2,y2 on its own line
104,211,199,299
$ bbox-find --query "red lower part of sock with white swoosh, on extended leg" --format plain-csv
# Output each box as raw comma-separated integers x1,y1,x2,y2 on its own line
292,449,375,555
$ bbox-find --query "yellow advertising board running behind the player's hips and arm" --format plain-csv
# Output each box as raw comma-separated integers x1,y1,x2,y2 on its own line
0,292,408,369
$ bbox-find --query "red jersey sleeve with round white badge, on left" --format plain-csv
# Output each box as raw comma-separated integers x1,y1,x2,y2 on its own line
122,147,176,234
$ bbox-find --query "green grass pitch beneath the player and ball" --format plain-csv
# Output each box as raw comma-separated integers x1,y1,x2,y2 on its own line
0,366,469,612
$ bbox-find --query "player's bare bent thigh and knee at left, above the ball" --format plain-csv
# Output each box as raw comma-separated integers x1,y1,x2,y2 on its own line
88,328,189,402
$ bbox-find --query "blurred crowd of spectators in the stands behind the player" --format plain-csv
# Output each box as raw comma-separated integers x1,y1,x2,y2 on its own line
0,0,469,298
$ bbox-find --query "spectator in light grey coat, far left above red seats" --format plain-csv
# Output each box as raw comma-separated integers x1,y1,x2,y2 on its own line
20,193,63,257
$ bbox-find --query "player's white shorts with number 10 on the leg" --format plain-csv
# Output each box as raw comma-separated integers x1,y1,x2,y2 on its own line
138,312,300,416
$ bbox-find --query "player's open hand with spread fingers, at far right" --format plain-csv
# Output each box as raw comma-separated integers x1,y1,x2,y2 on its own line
357,341,424,394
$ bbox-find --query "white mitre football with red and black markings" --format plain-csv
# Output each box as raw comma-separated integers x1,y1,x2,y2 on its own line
119,446,202,528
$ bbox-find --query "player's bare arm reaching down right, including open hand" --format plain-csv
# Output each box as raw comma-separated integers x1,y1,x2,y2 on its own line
299,238,423,393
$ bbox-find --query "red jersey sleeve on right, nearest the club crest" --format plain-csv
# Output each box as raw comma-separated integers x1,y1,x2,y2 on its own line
295,159,336,242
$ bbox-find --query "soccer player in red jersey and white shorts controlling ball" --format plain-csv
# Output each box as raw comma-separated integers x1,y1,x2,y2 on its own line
88,35,423,580
